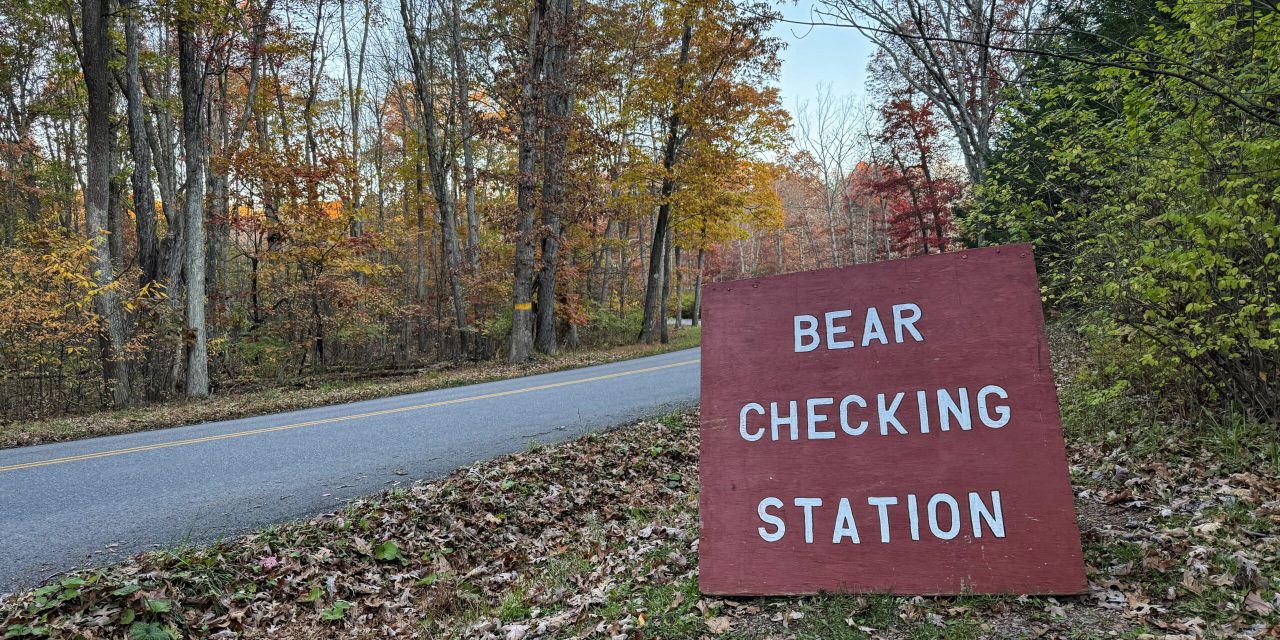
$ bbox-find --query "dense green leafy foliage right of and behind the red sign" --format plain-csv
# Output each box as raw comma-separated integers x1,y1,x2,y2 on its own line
965,0,1280,420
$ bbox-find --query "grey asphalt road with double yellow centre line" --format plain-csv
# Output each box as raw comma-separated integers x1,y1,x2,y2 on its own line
0,349,700,593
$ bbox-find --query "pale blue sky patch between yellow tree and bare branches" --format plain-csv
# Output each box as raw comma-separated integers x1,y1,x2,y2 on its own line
772,0,874,113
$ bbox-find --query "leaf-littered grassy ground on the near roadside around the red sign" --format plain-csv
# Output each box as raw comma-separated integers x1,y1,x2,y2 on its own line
0,330,1280,640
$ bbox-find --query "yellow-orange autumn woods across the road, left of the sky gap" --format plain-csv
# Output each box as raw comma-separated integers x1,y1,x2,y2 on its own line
0,0,786,416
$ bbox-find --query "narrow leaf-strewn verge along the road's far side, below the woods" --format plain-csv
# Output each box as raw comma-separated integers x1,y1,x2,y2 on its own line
0,326,701,449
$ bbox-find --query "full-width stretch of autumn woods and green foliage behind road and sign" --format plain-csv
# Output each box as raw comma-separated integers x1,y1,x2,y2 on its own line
0,0,1280,427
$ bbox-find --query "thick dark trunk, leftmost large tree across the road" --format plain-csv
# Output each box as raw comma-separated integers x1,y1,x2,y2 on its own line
81,0,132,407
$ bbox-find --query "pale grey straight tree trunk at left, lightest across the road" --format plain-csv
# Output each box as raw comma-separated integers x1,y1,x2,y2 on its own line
177,10,209,398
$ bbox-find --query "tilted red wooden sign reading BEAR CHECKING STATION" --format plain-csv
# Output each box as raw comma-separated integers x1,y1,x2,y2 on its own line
699,244,1085,595
